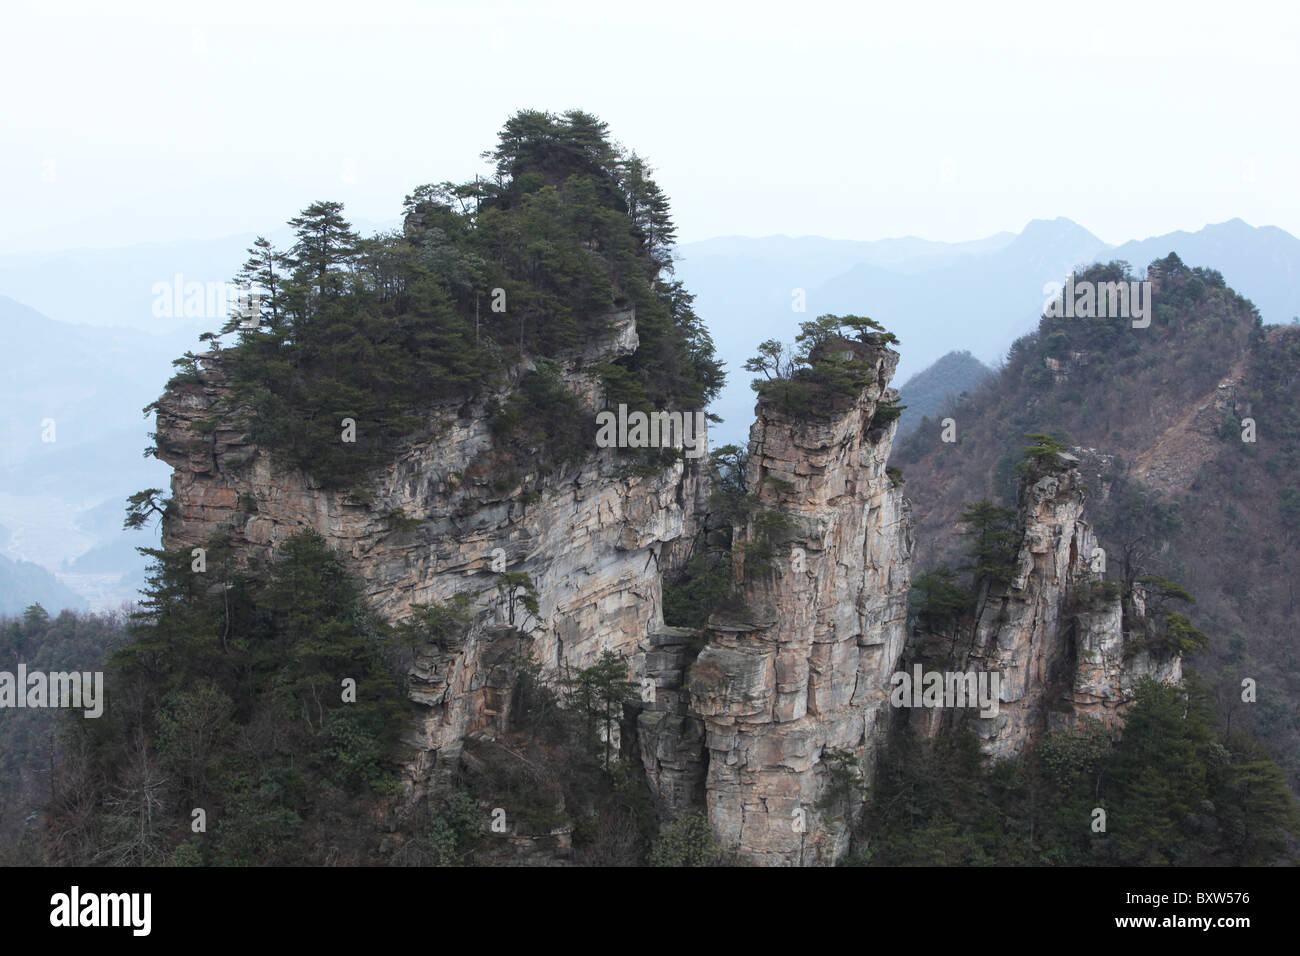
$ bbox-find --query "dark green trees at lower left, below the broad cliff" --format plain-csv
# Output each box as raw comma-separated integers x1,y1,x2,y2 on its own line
49,530,407,864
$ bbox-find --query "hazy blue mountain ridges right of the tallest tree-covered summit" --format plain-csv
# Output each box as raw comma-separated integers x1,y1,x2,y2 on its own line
677,219,1300,446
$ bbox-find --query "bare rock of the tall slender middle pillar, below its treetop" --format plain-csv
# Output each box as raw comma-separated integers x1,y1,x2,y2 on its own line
688,349,911,865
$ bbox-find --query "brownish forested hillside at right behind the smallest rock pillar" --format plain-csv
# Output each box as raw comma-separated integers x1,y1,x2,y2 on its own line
893,255,1300,788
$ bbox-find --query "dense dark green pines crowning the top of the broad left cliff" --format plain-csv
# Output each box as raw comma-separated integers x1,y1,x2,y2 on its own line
170,111,723,486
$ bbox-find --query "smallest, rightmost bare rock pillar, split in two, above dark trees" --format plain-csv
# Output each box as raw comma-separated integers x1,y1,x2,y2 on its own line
919,455,1182,760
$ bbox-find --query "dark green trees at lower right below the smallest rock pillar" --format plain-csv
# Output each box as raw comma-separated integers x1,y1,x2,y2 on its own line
850,679,1300,866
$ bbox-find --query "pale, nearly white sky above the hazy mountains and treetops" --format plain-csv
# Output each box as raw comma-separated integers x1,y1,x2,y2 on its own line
0,0,1300,252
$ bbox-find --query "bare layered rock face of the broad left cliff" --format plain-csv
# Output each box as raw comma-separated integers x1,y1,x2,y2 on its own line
156,312,702,795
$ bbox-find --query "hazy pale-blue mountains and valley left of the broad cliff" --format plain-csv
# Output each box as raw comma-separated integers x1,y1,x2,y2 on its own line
0,297,175,614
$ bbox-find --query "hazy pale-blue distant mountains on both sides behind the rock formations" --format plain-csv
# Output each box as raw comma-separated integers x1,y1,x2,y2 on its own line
0,219,1300,613
